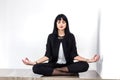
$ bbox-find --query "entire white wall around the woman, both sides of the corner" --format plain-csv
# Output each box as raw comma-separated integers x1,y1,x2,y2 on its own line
0,0,120,78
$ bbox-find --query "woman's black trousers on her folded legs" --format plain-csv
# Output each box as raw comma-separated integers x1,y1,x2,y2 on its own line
33,61,89,76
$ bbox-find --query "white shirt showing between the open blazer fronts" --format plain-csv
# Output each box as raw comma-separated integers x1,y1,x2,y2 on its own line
57,42,66,64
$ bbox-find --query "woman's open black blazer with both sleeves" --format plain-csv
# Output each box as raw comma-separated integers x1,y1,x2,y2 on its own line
45,33,78,64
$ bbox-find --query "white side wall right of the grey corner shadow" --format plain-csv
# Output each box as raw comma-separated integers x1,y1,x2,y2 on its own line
100,0,120,79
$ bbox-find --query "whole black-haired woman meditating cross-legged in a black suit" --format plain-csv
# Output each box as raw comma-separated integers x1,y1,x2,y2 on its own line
22,14,100,76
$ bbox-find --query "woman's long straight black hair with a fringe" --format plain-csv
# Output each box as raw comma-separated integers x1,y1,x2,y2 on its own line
53,14,70,35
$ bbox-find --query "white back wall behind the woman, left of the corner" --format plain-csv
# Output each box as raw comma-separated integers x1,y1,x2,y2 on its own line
0,0,99,70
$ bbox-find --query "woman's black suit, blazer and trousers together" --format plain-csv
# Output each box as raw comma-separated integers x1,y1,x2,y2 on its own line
33,33,89,75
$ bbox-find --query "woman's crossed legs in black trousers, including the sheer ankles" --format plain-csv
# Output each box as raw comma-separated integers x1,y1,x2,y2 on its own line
33,61,89,76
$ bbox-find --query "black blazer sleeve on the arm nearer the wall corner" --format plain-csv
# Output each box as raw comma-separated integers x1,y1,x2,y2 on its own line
71,34,78,59
